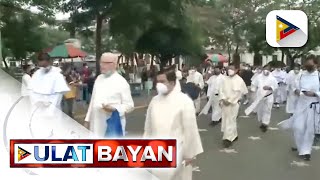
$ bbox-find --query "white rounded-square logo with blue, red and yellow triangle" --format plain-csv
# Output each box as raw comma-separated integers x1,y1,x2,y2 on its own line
266,10,308,47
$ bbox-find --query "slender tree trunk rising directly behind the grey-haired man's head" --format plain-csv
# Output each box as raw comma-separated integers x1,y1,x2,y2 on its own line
96,13,103,75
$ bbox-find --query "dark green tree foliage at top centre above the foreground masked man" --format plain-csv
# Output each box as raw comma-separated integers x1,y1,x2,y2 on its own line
110,0,203,66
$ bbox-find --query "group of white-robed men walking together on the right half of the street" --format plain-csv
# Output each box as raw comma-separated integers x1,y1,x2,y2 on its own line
195,56,320,161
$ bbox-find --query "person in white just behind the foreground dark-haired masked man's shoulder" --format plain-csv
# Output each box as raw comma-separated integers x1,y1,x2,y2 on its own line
187,67,204,114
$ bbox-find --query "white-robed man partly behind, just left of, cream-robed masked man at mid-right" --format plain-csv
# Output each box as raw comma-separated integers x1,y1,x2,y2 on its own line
200,67,225,126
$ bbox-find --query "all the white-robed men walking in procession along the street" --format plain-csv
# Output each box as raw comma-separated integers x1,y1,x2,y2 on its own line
19,53,320,180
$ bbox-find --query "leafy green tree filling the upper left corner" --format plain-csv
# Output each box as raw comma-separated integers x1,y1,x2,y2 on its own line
0,0,59,68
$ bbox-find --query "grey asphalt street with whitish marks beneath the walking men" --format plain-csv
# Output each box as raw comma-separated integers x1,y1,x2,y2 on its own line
74,96,320,180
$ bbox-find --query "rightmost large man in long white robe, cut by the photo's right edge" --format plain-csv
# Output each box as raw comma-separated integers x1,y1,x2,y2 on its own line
280,56,320,161
